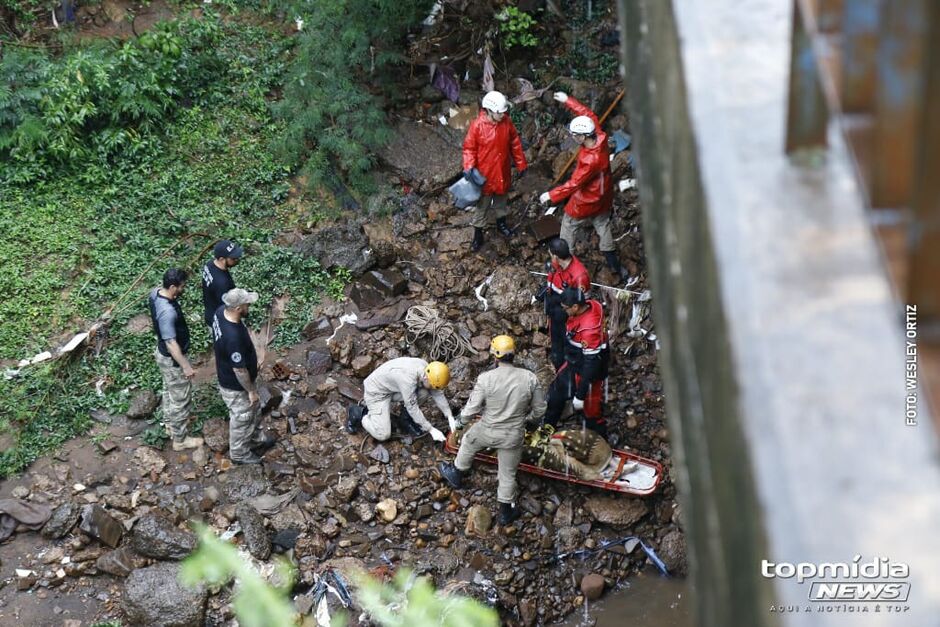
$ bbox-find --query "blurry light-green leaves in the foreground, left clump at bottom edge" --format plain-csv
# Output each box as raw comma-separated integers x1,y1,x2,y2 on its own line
180,525,295,627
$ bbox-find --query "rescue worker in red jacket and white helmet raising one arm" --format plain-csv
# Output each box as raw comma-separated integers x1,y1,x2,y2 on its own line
539,91,626,282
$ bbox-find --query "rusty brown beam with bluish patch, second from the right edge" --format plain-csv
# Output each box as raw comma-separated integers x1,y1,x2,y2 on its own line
872,0,927,207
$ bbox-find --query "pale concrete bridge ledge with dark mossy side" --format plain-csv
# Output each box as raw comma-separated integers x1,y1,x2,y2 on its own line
619,0,940,627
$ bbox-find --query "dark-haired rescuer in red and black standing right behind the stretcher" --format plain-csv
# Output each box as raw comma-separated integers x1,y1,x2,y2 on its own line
545,288,610,438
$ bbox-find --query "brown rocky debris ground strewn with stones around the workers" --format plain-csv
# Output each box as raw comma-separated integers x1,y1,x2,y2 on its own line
0,4,686,627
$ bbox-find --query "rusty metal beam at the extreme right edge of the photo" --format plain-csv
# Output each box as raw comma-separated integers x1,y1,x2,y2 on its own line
907,2,940,323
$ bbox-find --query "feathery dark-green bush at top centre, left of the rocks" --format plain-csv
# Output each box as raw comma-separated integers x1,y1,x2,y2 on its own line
276,0,431,190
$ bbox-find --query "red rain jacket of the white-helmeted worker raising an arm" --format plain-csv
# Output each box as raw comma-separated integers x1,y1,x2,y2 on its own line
548,96,614,220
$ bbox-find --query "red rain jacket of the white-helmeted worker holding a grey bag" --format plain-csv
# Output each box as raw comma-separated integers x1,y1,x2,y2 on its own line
463,109,529,196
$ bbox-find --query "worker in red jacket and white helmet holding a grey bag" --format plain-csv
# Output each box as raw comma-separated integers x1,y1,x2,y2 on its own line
463,91,529,251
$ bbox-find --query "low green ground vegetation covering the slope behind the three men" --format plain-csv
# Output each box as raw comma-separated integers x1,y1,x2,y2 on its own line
0,15,344,477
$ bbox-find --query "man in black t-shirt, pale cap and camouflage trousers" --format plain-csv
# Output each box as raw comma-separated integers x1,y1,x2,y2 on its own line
211,288,274,464
